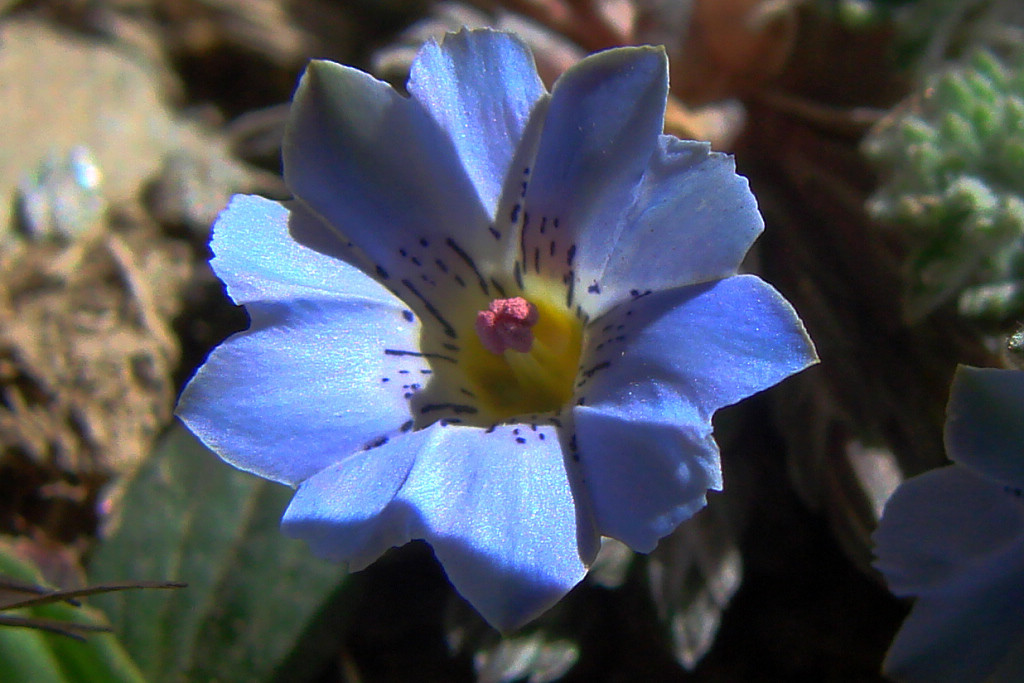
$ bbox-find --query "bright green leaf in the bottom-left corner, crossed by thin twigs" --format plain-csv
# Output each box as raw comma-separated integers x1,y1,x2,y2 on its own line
0,543,144,683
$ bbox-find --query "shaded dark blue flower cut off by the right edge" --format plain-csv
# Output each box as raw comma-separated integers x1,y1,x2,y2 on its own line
874,366,1024,683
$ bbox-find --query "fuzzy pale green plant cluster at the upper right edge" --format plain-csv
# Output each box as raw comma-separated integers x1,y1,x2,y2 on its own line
864,50,1024,322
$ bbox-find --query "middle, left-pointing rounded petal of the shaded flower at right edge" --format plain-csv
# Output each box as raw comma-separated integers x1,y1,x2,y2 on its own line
872,465,1024,596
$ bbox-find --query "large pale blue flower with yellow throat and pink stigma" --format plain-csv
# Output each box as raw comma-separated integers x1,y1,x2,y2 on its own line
177,31,816,631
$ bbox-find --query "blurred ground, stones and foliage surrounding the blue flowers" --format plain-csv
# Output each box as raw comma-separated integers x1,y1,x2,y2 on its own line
0,0,1024,683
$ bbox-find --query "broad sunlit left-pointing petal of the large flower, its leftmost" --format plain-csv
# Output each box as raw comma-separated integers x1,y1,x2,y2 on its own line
177,294,429,484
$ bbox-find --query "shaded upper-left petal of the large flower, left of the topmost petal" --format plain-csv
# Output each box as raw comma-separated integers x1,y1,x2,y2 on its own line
284,61,504,315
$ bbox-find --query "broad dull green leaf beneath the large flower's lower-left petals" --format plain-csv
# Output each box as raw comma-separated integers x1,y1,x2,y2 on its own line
90,425,351,683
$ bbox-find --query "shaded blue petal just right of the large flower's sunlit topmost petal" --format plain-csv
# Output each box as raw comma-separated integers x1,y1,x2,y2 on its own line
512,47,668,305
